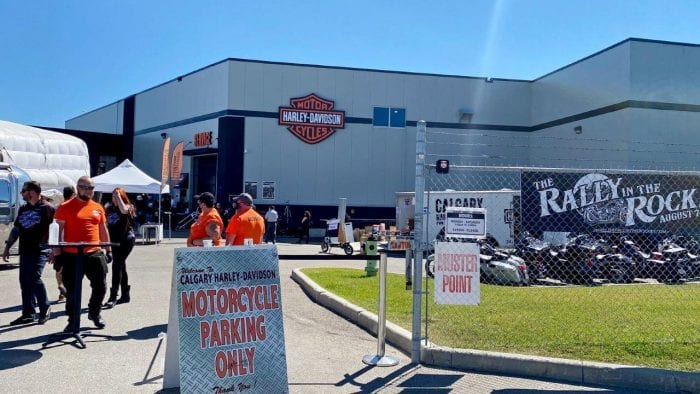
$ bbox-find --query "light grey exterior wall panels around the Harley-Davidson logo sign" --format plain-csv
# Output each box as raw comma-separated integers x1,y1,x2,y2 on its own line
66,40,700,206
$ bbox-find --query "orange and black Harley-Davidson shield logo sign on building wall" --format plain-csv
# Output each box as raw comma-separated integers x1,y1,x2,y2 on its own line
279,94,345,144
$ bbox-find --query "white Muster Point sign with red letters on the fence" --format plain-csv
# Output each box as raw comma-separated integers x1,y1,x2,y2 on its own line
433,242,481,305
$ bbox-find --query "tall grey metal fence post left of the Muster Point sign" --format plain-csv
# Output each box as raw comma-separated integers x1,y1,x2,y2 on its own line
411,120,427,364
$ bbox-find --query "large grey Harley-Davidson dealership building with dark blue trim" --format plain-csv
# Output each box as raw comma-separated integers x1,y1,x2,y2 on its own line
65,39,700,224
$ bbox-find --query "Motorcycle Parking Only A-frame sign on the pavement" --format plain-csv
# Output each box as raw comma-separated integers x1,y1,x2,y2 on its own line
174,245,288,393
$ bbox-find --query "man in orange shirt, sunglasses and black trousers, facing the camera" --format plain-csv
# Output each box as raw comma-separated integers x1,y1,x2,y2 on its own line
54,176,112,332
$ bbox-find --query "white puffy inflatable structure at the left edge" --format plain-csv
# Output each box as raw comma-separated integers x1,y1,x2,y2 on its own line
0,120,90,197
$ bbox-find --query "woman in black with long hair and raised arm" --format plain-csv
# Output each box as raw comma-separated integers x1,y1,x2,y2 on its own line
104,187,136,308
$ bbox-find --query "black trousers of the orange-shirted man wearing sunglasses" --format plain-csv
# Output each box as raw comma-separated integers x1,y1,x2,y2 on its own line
61,251,107,322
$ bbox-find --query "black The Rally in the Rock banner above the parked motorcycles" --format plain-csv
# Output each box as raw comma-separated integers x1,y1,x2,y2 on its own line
521,172,700,234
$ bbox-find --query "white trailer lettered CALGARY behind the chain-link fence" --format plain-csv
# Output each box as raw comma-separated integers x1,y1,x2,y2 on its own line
396,189,520,247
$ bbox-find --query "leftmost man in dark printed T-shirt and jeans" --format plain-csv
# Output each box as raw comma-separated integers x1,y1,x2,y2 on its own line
2,181,54,326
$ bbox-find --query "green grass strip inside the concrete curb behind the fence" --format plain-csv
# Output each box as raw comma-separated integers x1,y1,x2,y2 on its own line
302,268,700,371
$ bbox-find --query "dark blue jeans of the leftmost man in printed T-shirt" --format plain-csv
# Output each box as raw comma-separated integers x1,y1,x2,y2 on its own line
19,252,50,316
